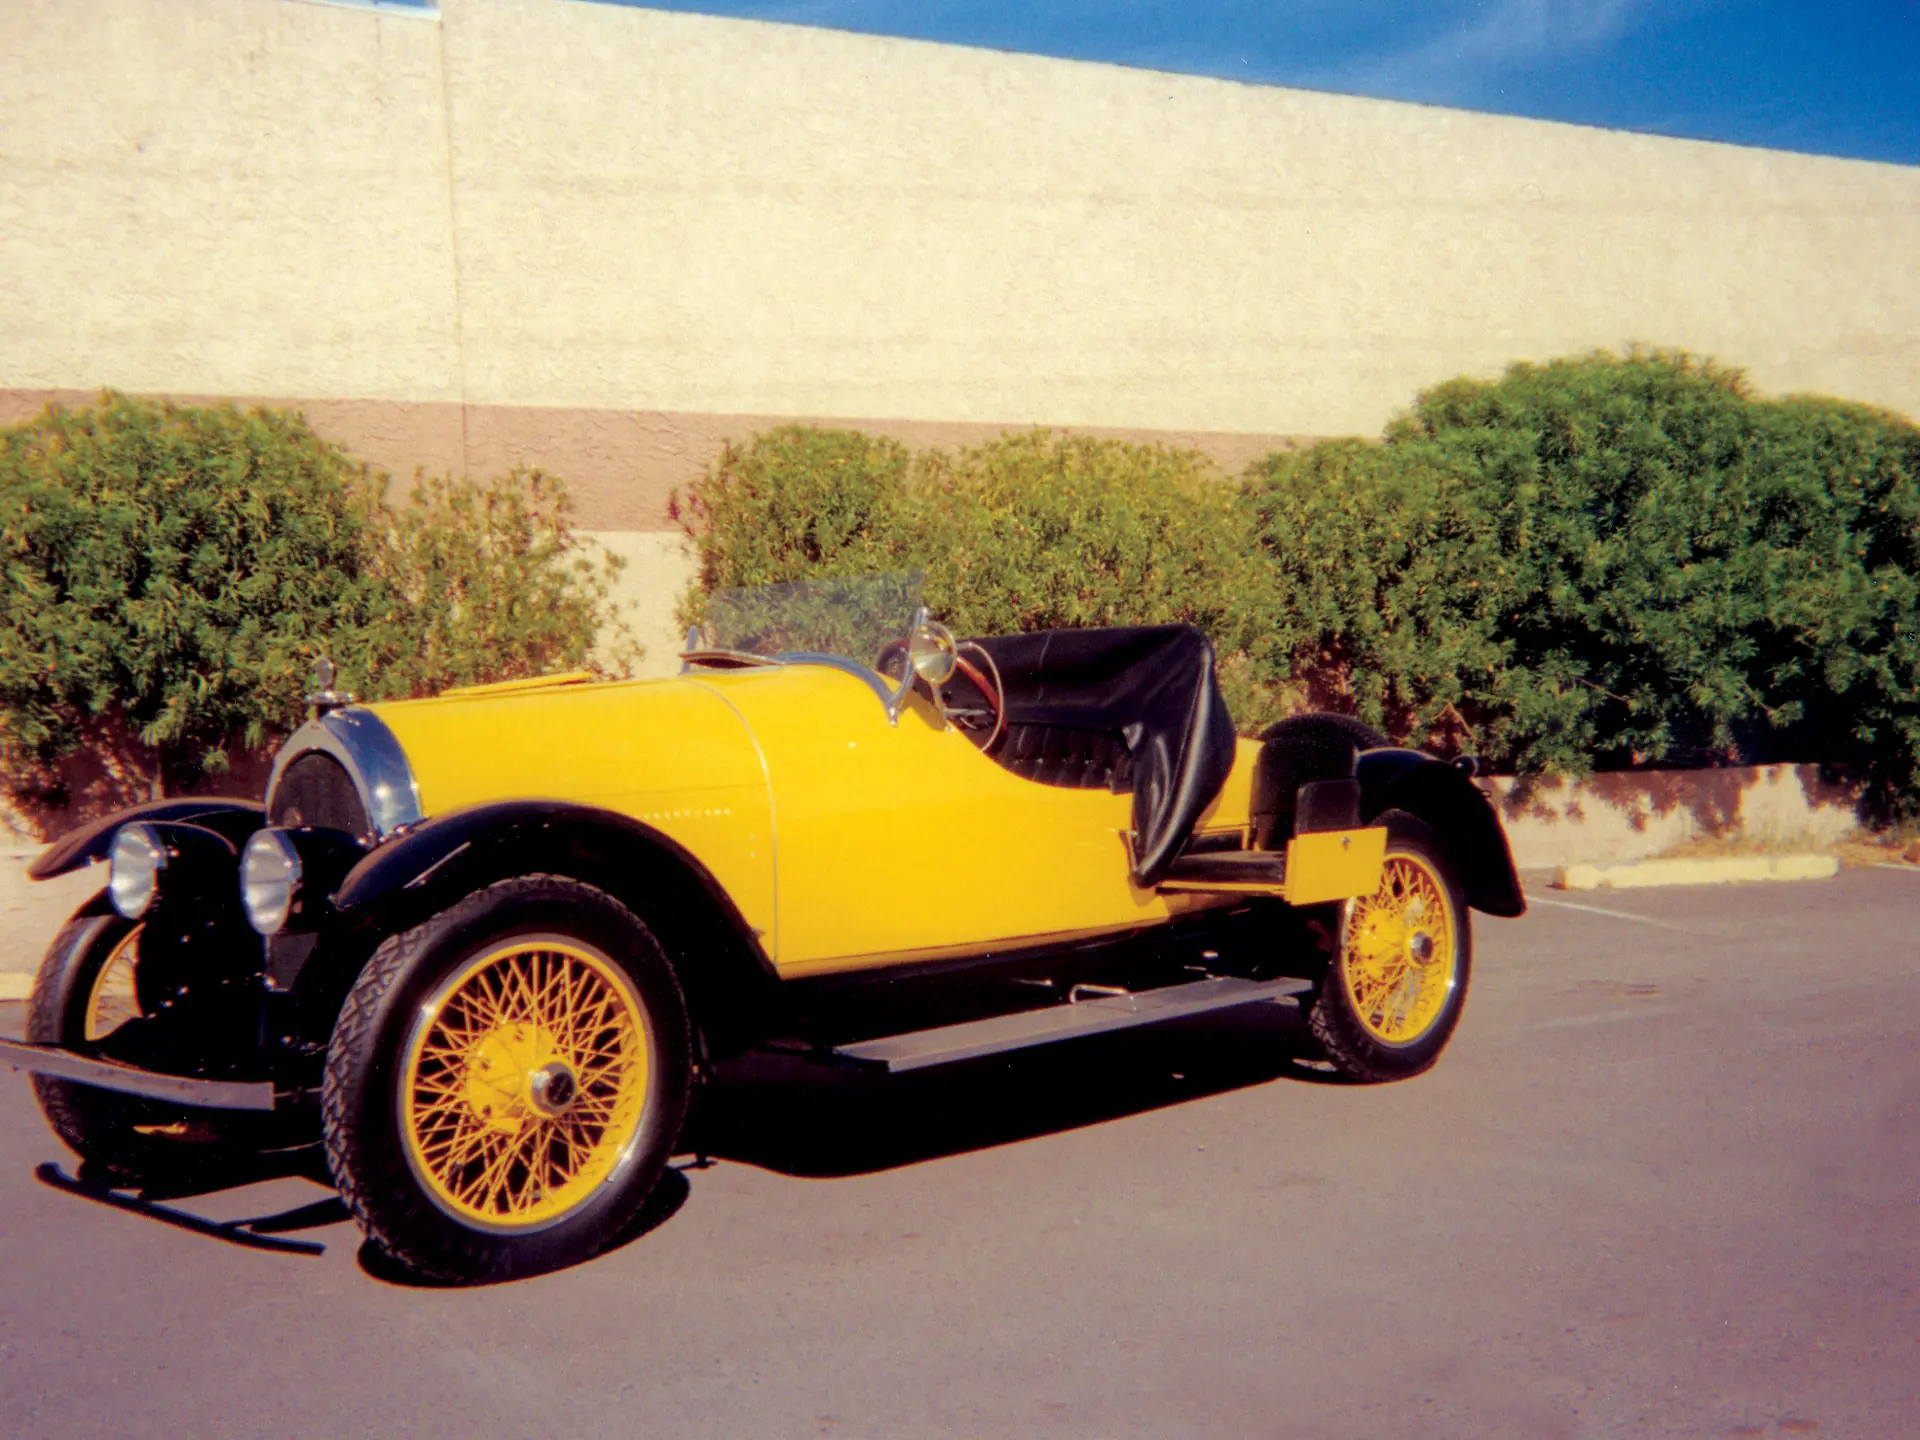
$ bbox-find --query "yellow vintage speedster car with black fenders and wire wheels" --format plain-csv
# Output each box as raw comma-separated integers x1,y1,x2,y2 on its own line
4,589,1523,1281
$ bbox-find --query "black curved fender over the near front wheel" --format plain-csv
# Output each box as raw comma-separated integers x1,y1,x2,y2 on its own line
315,801,778,1050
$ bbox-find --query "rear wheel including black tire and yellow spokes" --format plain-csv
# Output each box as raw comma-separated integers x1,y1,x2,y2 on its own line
1308,810,1473,1083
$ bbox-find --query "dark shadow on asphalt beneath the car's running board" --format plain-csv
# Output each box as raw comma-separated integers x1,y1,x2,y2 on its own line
680,1004,1344,1179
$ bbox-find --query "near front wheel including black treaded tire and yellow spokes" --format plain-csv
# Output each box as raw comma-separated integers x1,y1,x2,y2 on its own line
321,876,691,1283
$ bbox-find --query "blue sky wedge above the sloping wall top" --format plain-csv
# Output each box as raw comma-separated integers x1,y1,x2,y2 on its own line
616,0,1920,165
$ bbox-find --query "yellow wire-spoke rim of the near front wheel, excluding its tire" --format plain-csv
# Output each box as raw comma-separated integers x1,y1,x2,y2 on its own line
397,935,655,1231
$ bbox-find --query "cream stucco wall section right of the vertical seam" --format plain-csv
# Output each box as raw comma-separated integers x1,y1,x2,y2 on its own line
445,0,1920,434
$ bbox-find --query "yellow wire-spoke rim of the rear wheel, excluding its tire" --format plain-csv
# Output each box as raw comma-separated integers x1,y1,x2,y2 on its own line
1340,852,1457,1046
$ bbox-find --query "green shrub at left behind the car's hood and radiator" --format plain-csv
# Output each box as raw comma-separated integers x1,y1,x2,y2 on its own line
0,394,629,821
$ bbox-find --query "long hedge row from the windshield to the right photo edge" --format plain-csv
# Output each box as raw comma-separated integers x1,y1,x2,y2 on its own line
678,353,1920,810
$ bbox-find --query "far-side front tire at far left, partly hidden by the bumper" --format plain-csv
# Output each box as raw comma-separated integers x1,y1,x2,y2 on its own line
27,895,248,1181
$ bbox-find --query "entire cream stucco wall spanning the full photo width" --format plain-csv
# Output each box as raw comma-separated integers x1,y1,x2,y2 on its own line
0,0,1920,528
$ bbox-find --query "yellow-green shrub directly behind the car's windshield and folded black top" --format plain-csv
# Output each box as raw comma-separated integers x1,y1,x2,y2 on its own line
674,426,1286,716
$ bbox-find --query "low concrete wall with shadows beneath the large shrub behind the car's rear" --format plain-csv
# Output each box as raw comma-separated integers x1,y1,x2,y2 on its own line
1492,764,1859,870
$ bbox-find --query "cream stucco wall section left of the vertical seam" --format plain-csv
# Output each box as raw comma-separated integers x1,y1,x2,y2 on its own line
0,0,461,401
